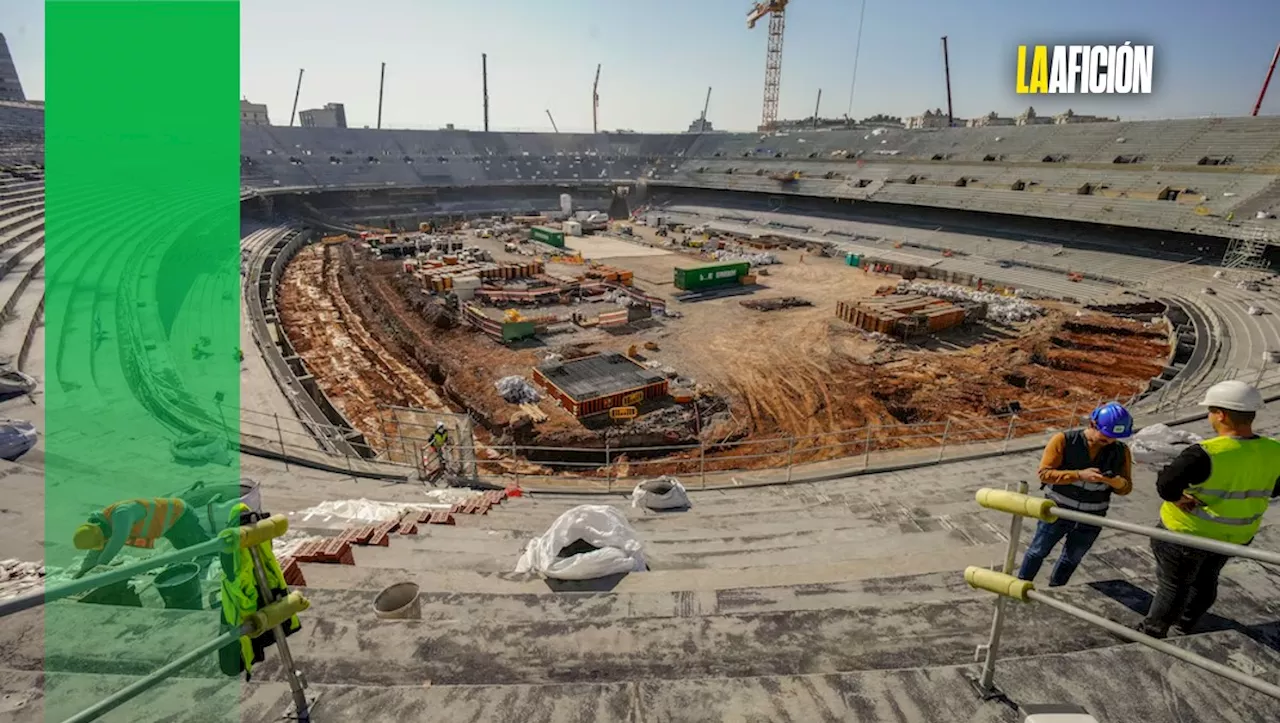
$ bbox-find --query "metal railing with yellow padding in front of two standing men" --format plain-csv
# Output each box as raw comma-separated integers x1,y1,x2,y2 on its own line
964,482,1280,700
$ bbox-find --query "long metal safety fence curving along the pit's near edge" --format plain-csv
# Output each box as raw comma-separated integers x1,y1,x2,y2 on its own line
223,355,1280,490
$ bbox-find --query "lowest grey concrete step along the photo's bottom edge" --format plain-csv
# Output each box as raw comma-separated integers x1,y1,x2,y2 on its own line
10,632,1280,723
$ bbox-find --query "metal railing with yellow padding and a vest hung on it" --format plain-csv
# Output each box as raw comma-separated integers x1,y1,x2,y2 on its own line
0,514,311,723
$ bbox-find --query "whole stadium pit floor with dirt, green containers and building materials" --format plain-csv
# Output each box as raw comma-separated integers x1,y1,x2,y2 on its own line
280,210,1174,473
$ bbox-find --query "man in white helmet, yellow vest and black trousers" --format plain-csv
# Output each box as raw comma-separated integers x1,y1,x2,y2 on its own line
1137,381,1280,637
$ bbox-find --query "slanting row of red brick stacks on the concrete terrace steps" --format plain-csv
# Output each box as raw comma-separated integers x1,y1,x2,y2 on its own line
280,490,520,587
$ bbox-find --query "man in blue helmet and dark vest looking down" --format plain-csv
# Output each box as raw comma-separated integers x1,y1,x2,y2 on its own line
1018,402,1133,587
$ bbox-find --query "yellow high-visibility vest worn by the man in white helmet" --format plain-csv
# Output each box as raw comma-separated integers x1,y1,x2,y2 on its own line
1160,436,1280,545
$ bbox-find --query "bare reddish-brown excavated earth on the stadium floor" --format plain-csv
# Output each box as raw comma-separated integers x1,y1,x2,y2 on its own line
282,239,1169,475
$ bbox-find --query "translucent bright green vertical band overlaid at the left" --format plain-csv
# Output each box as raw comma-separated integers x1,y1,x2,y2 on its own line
45,0,242,722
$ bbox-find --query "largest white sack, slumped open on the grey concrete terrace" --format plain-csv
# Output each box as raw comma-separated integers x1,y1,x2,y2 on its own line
516,504,645,580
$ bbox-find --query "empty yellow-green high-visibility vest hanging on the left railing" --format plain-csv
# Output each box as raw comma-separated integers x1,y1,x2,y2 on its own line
219,503,302,679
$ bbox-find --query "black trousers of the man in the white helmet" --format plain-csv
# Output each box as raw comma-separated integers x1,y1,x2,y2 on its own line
1140,527,1231,637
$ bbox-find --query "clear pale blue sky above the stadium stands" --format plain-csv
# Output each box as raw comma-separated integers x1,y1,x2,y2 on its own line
0,0,1280,131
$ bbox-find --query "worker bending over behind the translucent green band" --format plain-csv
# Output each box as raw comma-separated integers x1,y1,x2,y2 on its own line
72,498,210,578
